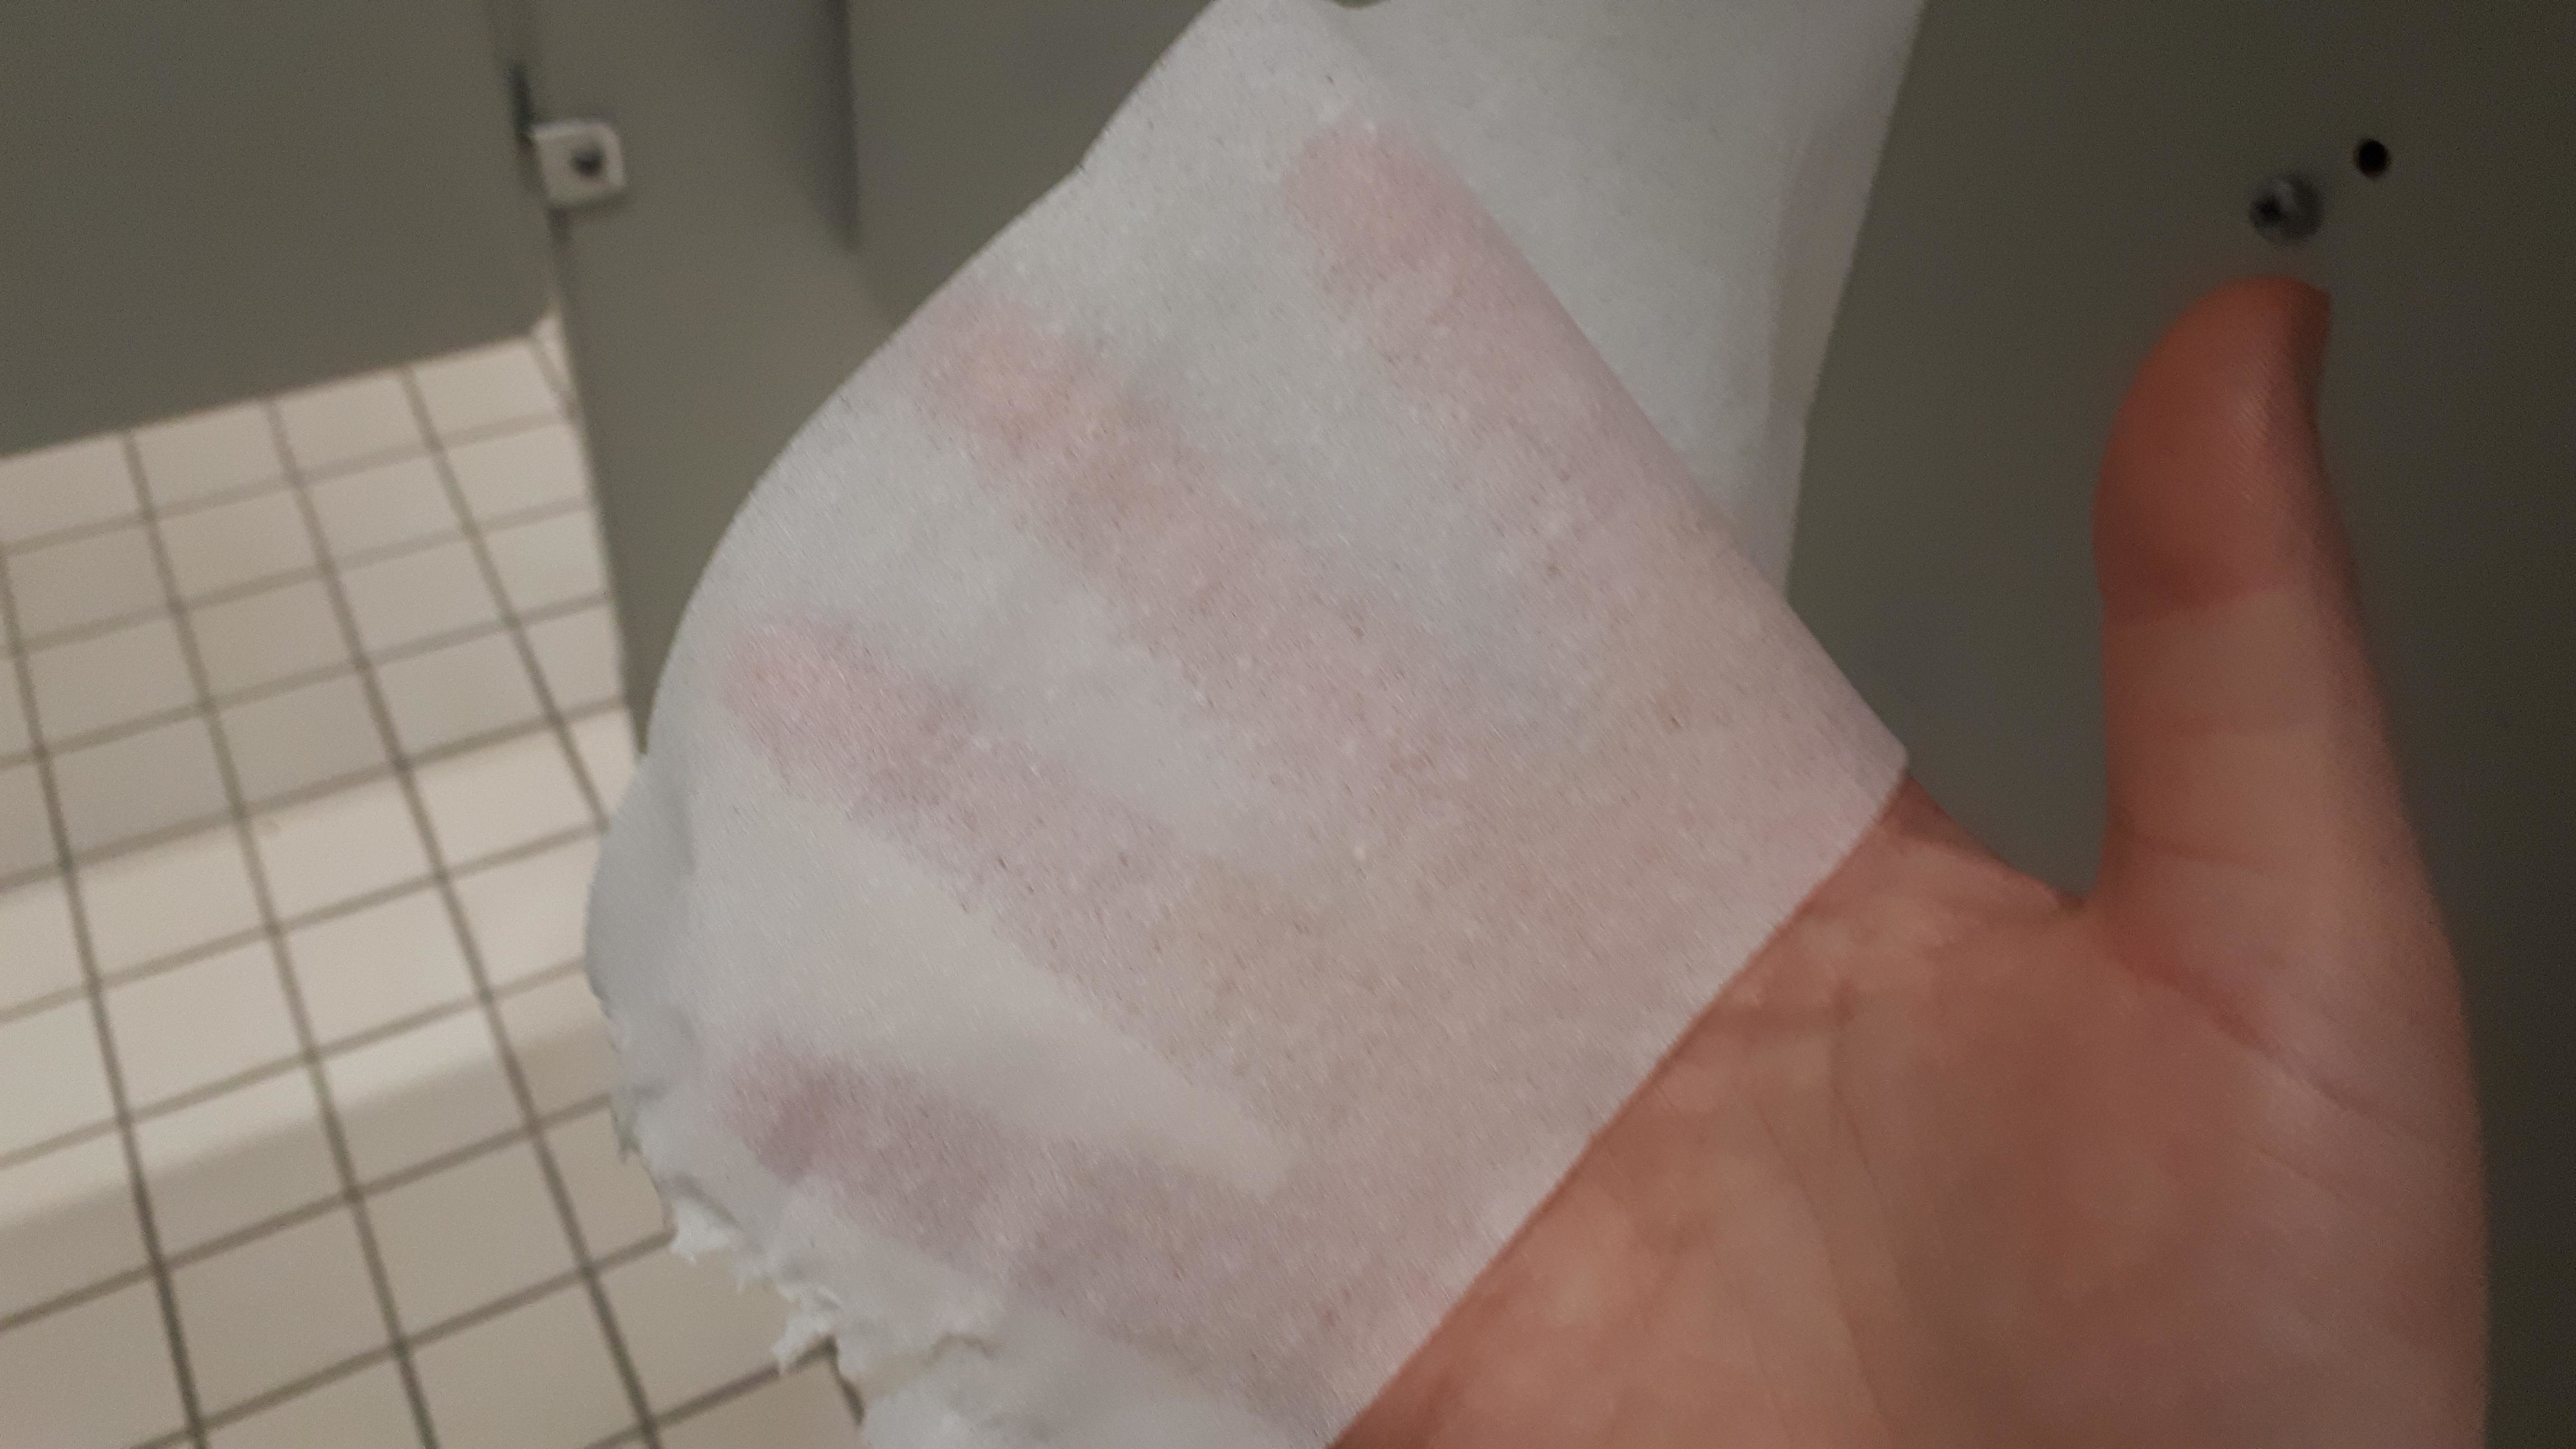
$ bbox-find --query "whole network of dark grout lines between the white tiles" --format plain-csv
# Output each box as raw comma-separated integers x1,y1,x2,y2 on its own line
0,348,659,1446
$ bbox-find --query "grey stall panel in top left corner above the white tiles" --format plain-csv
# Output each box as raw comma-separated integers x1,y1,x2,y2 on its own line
0,0,546,454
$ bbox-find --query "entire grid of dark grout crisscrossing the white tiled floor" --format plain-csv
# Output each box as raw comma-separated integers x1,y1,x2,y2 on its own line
0,335,860,1449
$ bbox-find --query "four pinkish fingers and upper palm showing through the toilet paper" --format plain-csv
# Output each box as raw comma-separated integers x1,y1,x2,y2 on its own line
696,107,1844,1397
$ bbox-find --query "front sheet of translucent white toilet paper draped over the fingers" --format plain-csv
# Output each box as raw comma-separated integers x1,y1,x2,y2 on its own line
590,0,1901,1449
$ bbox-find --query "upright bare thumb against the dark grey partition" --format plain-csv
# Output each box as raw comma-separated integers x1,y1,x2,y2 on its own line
2094,278,2414,923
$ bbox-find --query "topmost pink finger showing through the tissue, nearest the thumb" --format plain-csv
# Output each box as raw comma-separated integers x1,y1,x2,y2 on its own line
1288,121,1765,709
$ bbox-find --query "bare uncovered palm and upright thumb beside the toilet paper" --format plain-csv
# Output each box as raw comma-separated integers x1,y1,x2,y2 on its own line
1342,281,2486,1449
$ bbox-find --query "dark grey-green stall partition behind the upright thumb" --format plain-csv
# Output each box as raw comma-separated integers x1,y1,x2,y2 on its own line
1793,0,2576,1446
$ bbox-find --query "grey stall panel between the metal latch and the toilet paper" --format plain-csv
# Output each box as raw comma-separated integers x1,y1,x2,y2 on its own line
526,0,1203,706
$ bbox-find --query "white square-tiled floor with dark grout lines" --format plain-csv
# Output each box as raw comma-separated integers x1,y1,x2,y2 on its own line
0,321,853,1449
